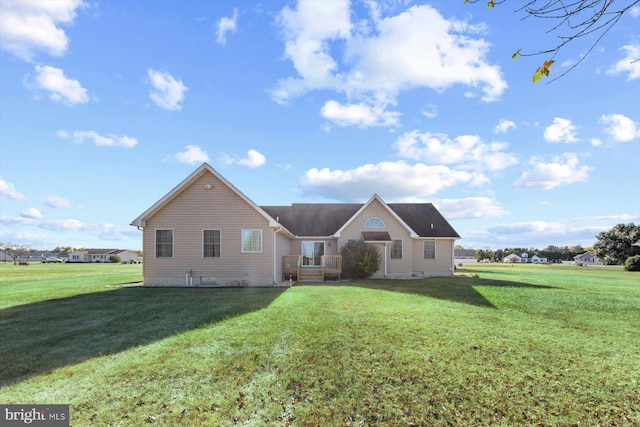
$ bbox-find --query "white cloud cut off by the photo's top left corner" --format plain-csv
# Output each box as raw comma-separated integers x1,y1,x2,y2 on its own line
0,0,84,61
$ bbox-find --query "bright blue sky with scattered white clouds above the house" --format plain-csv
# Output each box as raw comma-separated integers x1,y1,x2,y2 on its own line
0,0,640,250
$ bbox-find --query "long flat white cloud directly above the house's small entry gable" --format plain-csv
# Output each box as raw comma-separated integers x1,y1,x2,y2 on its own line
300,161,488,201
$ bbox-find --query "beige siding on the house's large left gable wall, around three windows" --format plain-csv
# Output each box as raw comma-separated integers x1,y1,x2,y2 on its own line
142,173,282,286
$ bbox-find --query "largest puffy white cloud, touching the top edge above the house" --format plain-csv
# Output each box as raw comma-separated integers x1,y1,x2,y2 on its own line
272,0,507,117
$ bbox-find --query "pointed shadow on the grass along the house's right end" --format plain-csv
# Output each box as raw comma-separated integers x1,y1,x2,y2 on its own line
322,276,554,308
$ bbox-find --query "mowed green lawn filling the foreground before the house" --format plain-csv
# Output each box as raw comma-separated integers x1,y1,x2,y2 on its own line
0,265,640,426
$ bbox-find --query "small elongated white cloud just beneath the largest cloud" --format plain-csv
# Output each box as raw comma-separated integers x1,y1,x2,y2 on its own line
320,100,400,128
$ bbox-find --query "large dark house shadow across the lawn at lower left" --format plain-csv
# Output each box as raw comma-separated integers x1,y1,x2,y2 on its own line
0,287,286,387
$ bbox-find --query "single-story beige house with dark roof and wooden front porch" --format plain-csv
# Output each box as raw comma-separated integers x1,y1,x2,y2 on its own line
131,163,460,286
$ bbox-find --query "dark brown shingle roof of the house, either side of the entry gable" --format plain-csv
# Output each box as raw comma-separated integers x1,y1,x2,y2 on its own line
260,203,460,238
